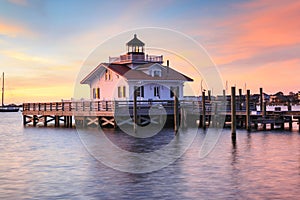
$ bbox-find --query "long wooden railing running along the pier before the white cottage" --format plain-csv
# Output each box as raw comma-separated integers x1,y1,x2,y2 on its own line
23,100,298,115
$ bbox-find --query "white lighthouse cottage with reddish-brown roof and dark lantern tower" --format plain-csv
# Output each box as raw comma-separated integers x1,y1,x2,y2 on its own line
80,34,193,100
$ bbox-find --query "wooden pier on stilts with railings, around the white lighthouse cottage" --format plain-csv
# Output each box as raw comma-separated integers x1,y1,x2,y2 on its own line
23,91,300,132
